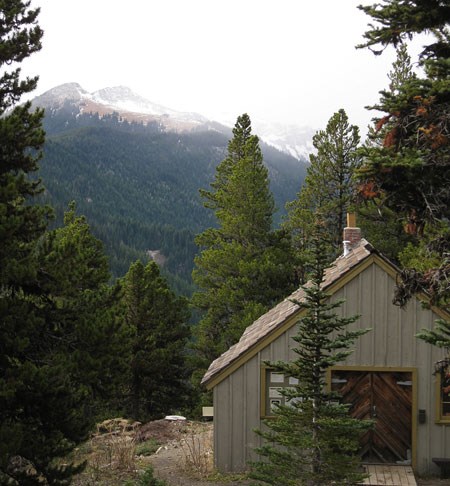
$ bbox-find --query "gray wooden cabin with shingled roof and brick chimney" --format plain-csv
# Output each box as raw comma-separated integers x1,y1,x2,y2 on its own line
202,218,450,475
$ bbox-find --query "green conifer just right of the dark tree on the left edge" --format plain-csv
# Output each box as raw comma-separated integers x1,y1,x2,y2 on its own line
38,202,128,421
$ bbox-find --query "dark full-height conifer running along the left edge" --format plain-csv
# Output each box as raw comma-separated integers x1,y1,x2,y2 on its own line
0,0,110,485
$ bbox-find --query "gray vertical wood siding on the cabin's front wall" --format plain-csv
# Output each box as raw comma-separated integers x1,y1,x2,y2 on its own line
214,264,450,474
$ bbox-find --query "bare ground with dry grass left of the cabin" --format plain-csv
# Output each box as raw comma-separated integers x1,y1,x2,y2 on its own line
71,419,249,486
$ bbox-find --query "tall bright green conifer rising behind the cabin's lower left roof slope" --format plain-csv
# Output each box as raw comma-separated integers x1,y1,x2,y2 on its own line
193,114,294,373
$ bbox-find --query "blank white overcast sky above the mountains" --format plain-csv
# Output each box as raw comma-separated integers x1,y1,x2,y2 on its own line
22,0,426,131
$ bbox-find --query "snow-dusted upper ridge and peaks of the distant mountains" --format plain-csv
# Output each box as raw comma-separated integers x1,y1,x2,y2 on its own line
32,83,315,161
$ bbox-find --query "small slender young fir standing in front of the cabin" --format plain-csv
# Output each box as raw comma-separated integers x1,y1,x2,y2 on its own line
251,224,370,486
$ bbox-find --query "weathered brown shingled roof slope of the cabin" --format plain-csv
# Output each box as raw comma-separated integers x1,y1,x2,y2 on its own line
202,239,378,385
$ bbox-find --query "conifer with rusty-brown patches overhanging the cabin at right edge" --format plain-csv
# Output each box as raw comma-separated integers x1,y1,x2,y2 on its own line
359,0,450,304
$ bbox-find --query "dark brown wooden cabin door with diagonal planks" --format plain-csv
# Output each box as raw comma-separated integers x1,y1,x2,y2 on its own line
331,370,412,463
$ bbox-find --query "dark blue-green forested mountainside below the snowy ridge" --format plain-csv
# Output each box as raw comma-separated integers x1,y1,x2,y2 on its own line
40,110,305,293
